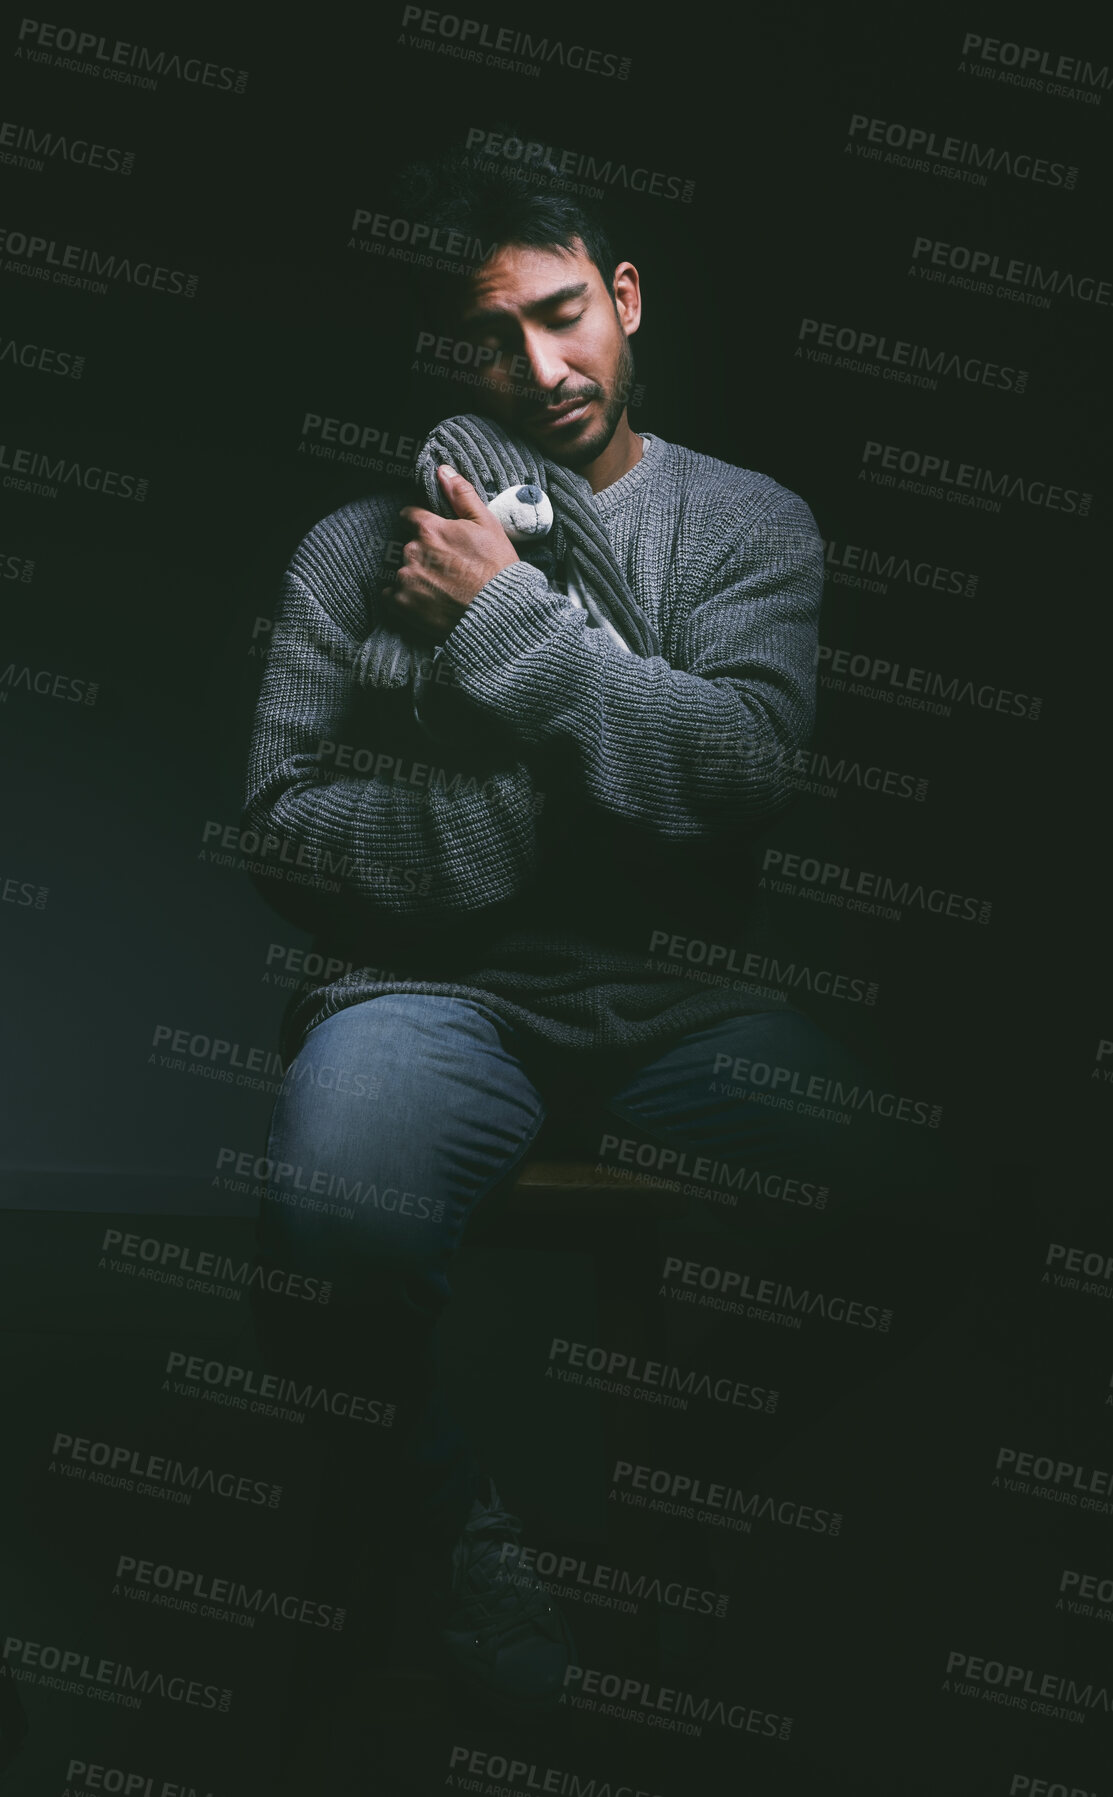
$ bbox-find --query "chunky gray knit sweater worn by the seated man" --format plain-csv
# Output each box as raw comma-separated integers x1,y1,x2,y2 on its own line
243,431,824,1055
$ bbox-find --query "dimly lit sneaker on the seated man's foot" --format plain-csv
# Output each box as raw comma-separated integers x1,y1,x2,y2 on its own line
441,1479,575,1713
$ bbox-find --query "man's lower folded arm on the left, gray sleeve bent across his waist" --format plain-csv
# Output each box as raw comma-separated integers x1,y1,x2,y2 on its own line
243,571,536,918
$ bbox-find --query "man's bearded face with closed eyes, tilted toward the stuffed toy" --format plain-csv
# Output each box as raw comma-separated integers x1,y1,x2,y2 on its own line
462,241,642,469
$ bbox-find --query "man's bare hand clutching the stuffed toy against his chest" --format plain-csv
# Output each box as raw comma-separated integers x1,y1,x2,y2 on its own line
383,467,518,640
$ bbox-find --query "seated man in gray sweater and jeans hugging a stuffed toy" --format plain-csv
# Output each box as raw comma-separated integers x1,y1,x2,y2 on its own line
245,150,934,1707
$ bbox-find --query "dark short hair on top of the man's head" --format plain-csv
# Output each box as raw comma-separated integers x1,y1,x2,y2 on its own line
396,124,619,304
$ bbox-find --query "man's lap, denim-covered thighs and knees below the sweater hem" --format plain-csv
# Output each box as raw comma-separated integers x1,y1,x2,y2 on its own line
272,994,935,1222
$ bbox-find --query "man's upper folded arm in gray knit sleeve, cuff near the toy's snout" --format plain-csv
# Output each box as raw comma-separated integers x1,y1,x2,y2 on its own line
442,494,824,839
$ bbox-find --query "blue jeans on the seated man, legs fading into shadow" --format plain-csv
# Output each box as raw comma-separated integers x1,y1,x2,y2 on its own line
249,994,948,1566
